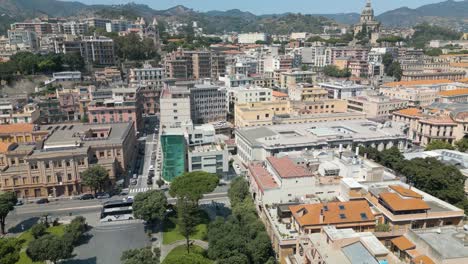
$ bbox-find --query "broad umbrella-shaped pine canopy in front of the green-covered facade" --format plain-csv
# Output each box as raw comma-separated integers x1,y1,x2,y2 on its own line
169,171,219,203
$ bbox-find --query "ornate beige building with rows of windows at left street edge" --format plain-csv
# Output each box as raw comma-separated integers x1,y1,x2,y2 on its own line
0,122,136,198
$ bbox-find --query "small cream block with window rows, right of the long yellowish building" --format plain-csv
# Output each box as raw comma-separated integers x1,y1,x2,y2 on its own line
347,95,408,119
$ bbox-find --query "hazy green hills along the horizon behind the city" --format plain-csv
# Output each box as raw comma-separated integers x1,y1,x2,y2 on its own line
0,0,468,34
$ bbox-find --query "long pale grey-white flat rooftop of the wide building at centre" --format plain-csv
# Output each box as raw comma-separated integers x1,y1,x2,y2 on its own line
236,119,406,147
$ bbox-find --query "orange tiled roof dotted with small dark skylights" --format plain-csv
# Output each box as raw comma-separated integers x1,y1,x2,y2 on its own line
289,201,375,226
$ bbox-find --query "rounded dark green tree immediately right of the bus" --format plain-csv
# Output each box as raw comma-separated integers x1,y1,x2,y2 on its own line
132,190,167,222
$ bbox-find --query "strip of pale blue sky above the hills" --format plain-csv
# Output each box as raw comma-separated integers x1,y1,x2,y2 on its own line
67,0,454,14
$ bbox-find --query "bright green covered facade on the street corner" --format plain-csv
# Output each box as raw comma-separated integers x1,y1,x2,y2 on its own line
161,135,186,182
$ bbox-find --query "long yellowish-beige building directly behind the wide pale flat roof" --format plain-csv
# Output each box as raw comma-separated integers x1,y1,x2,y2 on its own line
234,99,348,127
